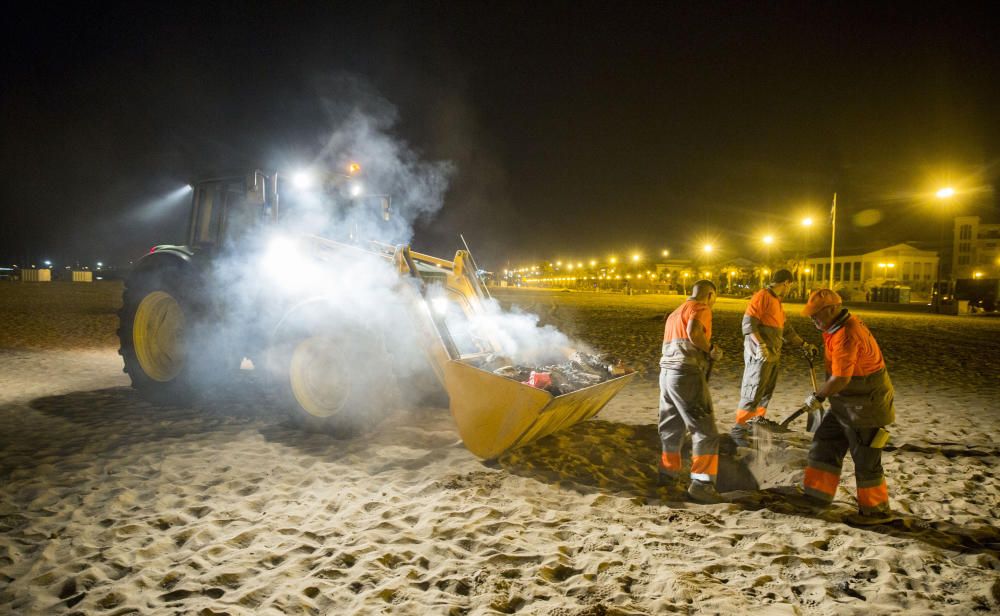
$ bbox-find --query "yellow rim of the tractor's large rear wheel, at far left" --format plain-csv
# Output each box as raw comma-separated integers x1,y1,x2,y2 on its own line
132,291,184,383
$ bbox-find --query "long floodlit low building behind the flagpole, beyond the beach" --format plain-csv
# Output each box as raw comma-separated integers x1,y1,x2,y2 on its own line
803,243,938,299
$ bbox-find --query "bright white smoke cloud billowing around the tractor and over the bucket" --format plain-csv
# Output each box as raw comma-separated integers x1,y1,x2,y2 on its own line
178,81,584,428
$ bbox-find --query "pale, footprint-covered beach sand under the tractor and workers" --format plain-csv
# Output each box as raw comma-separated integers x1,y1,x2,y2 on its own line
0,283,1000,615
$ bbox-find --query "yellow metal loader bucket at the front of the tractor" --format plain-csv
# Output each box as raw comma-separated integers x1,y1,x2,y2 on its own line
444,360,635,459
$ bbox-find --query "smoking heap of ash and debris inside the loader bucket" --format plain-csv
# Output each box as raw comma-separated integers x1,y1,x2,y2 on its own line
477,351,632,396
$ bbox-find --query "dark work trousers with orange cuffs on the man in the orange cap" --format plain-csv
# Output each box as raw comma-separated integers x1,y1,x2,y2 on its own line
803,411,889,515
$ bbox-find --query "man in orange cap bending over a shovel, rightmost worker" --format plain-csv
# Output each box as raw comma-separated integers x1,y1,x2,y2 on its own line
802,289,895,524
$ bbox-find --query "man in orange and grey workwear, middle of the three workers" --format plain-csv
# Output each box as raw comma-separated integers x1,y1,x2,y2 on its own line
730,269,819,447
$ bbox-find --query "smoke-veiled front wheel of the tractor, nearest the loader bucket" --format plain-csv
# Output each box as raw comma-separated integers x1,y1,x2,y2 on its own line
268,330,399,437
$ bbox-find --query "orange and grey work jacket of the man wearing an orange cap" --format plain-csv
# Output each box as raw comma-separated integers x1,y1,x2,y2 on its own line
823,308,896,428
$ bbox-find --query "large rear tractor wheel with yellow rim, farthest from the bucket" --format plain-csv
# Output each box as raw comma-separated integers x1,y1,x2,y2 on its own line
118,266,194,405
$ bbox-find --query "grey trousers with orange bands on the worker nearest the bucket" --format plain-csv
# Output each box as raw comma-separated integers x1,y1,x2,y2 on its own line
657,368,719,483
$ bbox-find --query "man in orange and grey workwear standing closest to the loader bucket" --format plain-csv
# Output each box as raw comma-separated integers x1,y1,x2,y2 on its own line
657,280,724,503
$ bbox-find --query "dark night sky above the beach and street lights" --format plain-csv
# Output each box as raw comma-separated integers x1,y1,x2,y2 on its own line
0,2,1000,269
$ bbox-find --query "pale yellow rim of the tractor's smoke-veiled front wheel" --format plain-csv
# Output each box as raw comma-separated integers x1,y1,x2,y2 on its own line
288,336,351,418
